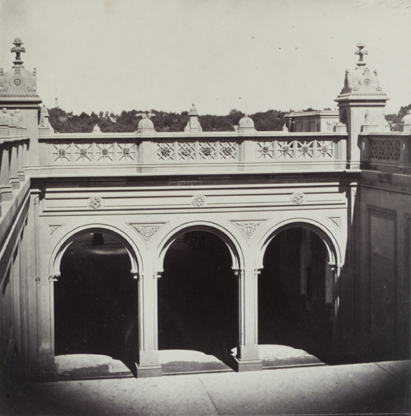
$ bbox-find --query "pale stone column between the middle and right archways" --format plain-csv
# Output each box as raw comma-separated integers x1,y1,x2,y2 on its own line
234,262,262,372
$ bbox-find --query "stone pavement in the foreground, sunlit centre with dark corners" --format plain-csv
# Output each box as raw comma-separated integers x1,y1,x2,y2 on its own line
0,360,411,416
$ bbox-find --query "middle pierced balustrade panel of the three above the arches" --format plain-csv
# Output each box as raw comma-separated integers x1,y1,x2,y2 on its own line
157,140,238,162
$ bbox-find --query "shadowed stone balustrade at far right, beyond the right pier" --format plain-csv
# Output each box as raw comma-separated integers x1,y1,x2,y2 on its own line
360,132,411,173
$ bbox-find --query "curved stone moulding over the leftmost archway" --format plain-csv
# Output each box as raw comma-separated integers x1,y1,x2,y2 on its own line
49,224,143,276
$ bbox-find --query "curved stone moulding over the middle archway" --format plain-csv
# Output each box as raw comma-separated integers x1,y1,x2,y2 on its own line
155,221,244,273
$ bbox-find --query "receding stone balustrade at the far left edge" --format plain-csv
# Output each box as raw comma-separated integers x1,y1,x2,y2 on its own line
0,136,29,216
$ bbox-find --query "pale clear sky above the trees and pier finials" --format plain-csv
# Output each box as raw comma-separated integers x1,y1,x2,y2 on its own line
0,0,411,115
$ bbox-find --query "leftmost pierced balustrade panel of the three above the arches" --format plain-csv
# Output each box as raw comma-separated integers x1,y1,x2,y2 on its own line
50,142,137,165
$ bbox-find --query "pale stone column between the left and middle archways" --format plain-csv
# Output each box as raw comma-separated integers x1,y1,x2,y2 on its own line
136,270,162,377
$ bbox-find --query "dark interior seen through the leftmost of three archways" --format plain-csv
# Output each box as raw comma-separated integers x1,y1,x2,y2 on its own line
54,231,138,362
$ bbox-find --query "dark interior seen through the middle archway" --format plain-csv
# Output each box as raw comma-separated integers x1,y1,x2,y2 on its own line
158,231,238,365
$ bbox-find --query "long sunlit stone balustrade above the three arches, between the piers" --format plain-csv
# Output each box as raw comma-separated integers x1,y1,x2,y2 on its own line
39,132,347,176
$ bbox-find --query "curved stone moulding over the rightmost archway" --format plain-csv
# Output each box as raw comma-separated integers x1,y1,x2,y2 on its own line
256,218,342,269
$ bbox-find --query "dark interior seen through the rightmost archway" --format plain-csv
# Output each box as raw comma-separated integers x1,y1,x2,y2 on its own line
258,227,333,361
